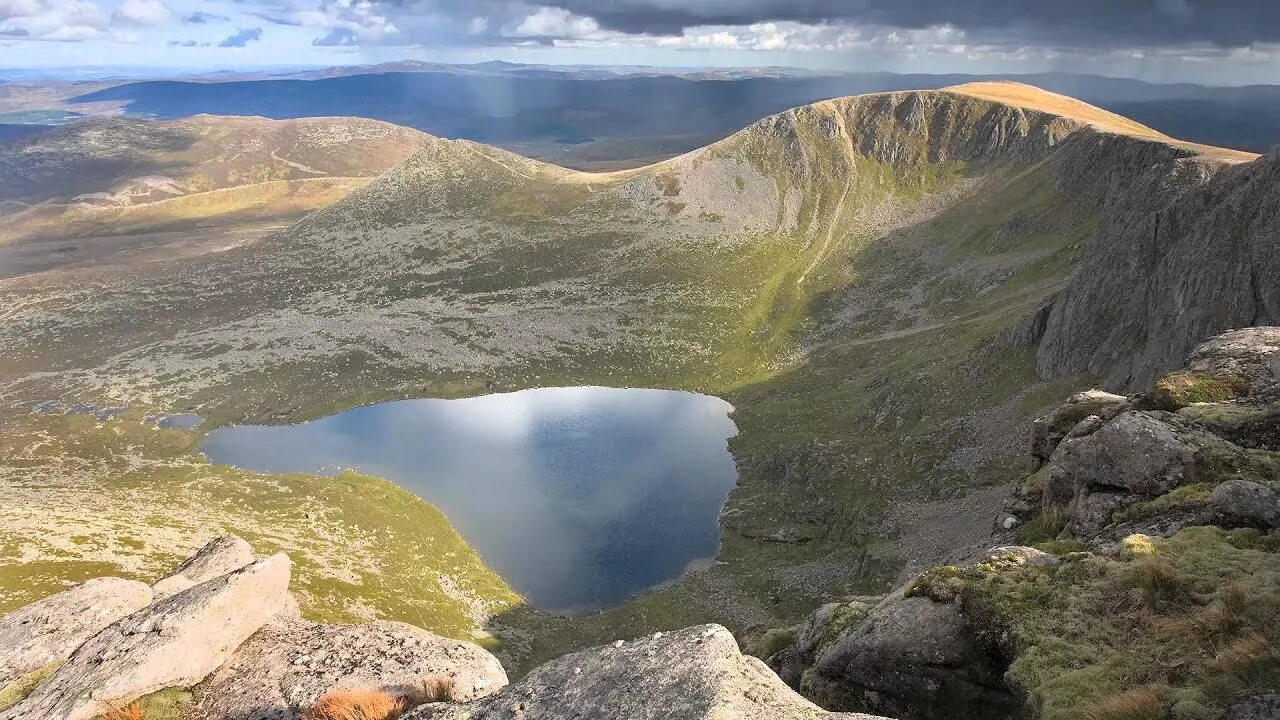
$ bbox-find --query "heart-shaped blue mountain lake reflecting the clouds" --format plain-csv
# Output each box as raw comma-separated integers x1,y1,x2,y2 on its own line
201,387,736,612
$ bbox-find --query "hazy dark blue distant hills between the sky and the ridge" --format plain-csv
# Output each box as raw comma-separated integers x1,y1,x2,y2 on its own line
0,61,1280,169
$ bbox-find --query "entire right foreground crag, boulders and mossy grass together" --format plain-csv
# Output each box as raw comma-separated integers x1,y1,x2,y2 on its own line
768,327,1280,720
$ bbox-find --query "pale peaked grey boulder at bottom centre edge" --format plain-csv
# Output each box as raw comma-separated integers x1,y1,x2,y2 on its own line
404,625,870,720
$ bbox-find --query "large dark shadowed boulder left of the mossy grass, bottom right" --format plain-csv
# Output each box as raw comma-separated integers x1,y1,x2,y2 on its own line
801,592,1021,720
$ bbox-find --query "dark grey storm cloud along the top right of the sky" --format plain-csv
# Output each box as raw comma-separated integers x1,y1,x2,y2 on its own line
527,0,1280,47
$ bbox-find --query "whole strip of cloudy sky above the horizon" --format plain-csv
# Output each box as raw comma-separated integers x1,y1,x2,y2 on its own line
0,0,1280,85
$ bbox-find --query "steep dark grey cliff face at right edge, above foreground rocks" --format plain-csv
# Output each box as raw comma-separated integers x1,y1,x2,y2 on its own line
1037,146,1280,389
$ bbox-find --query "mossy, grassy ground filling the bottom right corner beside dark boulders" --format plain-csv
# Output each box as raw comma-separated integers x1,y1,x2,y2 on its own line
959,527,1280,720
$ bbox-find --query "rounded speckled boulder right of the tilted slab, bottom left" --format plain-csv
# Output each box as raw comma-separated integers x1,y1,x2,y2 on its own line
200,620,507,720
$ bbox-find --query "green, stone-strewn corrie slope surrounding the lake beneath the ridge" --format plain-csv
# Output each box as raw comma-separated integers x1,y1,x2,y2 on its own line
0,87,1244,660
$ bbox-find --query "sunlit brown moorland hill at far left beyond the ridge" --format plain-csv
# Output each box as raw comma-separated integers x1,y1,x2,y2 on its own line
0,115,430,242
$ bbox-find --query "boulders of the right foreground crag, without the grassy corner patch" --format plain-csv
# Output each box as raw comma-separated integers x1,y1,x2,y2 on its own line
769,328,1280,719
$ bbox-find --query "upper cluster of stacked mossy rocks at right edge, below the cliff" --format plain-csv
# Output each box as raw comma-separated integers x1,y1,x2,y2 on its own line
1024,327,1280,547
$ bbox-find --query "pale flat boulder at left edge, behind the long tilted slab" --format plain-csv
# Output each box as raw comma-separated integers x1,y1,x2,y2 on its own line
0,578,151,688
